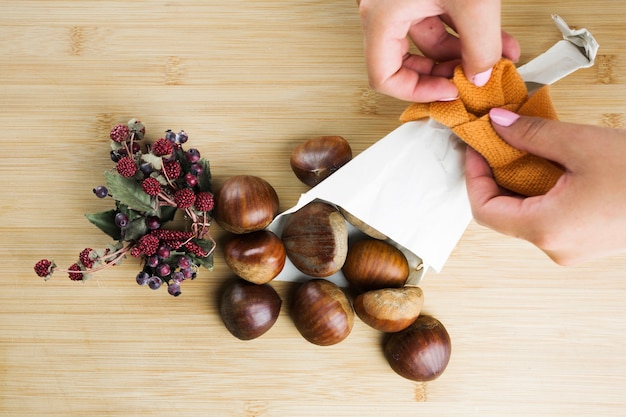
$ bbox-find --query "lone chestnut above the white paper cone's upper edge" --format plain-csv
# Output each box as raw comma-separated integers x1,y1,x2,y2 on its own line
290,136,352,187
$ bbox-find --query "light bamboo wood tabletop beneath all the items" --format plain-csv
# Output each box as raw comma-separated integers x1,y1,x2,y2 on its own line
0,0,626,417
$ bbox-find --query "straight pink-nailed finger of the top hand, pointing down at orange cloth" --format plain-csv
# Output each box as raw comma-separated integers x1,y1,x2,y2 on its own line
447,0,502,80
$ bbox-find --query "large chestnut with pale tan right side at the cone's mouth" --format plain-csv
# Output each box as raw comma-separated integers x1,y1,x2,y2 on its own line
281,201,348,278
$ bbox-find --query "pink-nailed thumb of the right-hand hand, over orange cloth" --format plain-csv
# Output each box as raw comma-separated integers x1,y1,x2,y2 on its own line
489,108,589,166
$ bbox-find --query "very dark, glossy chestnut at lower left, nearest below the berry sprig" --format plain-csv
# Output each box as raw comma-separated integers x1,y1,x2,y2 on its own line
220,278,282,340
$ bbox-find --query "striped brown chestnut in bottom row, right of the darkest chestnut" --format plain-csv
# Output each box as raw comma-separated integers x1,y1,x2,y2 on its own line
291,278,354,346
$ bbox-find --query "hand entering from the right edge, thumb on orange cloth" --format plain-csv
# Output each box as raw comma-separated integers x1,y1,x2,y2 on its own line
465,109,626,265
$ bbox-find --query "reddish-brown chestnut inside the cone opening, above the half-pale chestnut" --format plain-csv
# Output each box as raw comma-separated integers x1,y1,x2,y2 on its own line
342,238,409,291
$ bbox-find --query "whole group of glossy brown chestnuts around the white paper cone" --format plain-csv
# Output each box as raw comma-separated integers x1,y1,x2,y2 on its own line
214,136,451,381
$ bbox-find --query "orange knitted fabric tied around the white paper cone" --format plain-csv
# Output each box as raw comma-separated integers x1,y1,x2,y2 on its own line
400,59,563,196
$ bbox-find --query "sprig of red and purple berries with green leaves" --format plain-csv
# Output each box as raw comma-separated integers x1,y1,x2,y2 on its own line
34,119,216,296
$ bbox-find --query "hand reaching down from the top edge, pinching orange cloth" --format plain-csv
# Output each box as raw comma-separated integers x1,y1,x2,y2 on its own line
357,0,520,103
